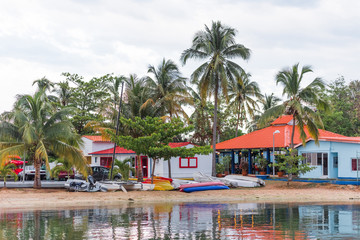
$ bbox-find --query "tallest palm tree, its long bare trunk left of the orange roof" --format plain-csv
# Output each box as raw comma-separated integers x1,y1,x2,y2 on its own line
181,22,250,176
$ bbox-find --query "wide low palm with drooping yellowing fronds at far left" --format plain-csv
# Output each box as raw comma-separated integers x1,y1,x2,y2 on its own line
0,90,87,188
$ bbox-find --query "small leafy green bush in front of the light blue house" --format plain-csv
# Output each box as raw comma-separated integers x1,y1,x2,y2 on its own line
274,148,314,185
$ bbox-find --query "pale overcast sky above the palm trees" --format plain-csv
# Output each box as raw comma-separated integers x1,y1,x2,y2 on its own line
0,0,360,113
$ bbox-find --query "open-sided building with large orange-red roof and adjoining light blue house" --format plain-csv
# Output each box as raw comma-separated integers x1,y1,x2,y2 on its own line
216,115,360,178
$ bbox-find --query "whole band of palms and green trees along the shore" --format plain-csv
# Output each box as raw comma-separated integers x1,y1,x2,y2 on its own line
0,22,360,188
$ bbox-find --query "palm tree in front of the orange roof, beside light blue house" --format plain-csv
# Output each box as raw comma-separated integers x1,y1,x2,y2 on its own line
260,64,329,148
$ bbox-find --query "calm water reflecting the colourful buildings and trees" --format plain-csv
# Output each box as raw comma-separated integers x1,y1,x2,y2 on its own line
0,203,360,239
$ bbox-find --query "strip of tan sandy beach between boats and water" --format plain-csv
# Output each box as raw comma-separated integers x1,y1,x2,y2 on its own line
0,181,360,209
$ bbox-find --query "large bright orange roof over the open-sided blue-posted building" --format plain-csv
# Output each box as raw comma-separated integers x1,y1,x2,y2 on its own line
216,116,348,150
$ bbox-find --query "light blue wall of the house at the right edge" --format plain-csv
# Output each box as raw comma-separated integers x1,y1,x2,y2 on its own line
298,141,360,178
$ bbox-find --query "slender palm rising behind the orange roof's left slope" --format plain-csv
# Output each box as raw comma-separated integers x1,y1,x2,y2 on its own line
228,72,261,137
